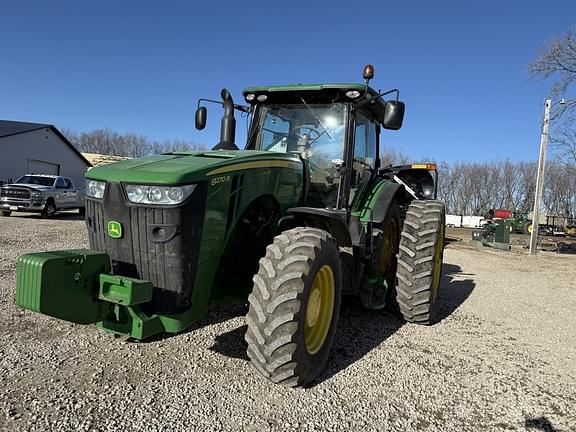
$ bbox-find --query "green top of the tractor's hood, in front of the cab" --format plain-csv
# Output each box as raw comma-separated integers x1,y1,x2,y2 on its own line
86,150,302,185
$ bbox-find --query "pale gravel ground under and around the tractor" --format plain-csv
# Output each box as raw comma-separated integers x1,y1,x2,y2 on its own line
0,215,576,431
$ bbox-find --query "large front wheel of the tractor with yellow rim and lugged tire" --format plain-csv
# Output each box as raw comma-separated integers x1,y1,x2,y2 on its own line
246,227,342,387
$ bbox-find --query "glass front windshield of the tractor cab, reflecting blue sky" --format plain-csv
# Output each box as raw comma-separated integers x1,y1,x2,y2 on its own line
255,101,348,207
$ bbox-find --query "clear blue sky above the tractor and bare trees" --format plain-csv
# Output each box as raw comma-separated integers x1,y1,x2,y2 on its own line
0,0,576,162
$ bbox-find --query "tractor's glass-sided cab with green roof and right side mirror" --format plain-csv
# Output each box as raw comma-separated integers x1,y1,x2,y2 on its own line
243,82,404,209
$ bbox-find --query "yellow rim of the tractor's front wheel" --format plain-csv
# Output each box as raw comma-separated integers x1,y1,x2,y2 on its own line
304,265,334,354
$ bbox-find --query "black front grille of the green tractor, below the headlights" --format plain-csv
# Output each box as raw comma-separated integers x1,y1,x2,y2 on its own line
86,183,206,313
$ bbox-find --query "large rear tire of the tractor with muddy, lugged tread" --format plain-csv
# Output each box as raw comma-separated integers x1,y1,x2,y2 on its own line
396,200,446,325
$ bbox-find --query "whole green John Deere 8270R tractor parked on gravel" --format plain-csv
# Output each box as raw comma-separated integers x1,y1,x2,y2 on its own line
16,66,445,386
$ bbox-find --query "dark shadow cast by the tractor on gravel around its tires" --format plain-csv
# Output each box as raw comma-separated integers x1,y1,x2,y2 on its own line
207,264,475,387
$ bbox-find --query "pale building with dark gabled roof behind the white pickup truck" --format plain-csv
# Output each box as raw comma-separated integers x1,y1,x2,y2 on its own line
0,120,92,186
